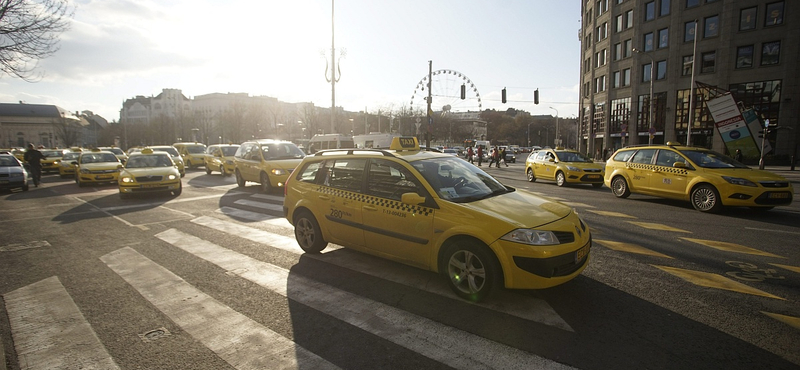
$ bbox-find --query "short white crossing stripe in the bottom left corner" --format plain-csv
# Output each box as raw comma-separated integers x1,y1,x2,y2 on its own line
3,276,119,370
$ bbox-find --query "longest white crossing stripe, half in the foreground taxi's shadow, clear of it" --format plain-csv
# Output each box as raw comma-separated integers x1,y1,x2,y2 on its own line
153,229,568,369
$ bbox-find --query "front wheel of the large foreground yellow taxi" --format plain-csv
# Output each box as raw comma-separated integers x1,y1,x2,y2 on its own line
441,241,502,302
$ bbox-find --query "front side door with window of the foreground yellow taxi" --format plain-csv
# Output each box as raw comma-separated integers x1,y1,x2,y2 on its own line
362,159,434,268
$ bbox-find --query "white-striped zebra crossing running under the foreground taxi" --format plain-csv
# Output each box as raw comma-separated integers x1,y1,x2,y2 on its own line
3,194,573,369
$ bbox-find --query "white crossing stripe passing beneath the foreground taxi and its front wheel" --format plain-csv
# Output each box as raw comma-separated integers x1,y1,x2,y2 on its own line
185,216,574,331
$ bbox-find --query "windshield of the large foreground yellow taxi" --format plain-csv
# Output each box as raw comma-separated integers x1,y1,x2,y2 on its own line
412,157,514,203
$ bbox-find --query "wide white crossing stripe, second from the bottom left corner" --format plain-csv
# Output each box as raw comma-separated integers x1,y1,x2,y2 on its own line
100,247,337,370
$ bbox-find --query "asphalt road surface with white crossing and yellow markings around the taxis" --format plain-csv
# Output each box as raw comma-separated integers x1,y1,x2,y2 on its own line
0,163,800,370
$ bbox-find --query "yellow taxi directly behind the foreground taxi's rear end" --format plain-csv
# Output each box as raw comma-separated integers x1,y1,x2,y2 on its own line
233,139,306,193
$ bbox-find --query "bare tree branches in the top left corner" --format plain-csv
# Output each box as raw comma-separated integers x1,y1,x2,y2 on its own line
0,0,74,82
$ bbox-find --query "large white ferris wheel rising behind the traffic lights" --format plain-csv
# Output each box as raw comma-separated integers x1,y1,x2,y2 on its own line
411,69,482,116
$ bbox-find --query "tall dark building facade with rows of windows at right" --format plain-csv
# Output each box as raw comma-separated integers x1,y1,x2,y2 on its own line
579,0,800,162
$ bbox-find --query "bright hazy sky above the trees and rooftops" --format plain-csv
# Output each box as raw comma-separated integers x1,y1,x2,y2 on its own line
0,0,580,121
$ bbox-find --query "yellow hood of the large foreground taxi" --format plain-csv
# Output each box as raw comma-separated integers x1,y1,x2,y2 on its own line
459,190,572,227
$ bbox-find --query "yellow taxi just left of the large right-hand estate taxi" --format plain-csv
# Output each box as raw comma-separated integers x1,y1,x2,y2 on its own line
525,148,604,188
